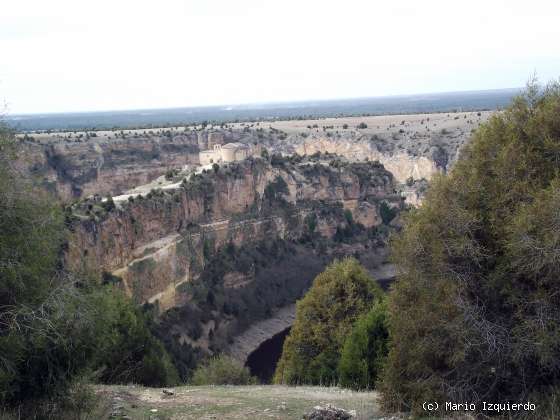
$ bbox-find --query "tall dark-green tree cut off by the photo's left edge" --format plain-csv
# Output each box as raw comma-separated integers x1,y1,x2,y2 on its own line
0,126,80,403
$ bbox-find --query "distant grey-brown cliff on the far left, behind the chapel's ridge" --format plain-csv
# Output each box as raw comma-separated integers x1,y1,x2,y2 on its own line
20,135,198,200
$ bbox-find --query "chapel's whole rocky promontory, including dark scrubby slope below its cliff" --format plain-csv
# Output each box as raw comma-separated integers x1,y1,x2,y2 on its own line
66,158,403,363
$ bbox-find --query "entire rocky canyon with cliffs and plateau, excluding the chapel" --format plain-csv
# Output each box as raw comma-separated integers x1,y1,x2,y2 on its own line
17,112,491,373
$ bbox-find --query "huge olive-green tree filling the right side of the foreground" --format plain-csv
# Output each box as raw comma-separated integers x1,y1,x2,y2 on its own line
383,79,560,418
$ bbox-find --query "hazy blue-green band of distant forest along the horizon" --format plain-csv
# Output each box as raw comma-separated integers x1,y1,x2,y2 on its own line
7,89,520,132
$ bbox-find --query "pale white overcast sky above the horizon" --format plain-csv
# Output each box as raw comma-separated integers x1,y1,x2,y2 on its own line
0,0,560,114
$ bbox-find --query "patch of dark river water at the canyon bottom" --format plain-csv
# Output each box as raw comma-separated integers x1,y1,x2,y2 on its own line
246,327,291,384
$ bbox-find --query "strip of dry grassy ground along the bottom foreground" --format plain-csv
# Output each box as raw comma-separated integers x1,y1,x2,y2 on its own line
95,385,383,420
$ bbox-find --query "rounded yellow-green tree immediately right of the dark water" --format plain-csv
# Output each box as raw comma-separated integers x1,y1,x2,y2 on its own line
274,258,383,384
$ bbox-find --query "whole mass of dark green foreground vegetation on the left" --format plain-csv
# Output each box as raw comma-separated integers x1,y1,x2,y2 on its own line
0,123,177,418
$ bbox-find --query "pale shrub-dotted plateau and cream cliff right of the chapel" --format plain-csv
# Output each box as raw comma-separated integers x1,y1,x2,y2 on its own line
243,111,492,183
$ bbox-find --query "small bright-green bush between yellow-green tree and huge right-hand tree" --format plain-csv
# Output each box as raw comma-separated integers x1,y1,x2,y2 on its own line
338,301,389,390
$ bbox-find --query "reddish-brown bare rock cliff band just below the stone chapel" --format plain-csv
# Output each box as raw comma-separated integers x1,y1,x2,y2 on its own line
67,159,401,309
